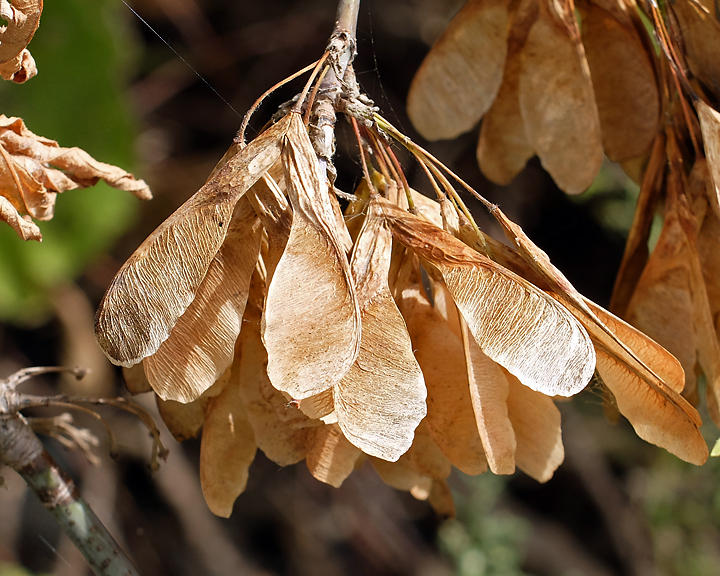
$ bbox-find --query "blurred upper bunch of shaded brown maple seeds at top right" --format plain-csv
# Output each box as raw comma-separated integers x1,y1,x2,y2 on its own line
408,0,660,194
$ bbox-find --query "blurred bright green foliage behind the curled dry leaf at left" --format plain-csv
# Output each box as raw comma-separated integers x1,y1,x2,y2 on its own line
0,0,139,323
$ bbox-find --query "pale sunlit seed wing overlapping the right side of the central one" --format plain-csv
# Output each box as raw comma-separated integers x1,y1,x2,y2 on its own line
333,201,427,461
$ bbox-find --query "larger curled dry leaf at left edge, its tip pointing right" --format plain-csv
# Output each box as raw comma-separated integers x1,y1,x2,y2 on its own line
0,114,151,240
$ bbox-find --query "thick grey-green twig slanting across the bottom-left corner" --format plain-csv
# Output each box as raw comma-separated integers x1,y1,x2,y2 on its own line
0,414,138,576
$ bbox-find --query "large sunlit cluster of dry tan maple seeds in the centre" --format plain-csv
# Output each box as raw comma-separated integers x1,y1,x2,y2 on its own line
96,97,707,516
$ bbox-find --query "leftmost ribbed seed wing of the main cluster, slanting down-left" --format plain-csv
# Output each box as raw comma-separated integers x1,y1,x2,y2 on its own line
95,117,289,366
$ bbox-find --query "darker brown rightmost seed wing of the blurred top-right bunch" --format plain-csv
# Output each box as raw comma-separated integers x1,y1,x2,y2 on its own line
581,1,660,162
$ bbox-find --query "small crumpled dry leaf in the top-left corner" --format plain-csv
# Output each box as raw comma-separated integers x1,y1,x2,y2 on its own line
0,0,43,84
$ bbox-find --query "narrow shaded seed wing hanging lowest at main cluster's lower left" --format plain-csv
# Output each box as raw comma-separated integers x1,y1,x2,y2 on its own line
200,366,257,518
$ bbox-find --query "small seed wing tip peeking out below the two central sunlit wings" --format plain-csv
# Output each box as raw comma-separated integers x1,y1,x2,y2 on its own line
305,424,362,488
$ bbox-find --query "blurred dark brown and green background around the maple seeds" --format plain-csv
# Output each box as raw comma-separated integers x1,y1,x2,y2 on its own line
0,0,720,576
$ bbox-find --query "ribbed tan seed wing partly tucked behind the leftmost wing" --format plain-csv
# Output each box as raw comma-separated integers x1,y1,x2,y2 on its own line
143,198,261,402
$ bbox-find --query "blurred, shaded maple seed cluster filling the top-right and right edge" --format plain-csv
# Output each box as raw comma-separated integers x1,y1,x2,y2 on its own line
408,0,720,454
